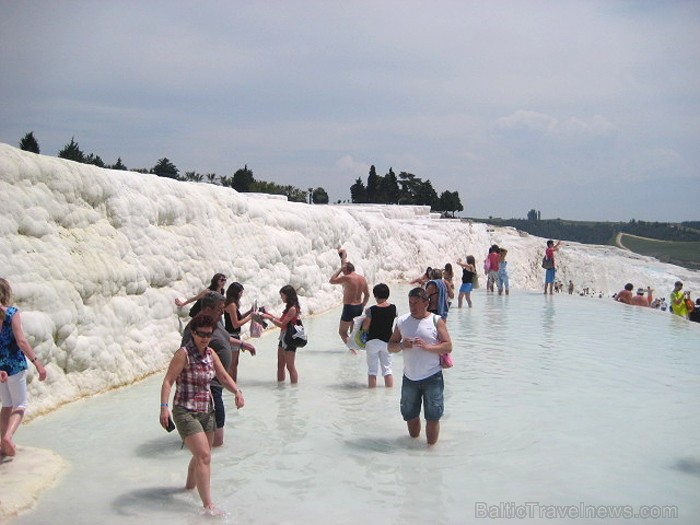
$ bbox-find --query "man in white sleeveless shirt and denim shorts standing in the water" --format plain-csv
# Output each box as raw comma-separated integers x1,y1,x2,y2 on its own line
389,288,452,445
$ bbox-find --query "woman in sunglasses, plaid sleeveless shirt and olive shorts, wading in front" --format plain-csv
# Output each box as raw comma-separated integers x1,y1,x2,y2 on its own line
160,314,245,515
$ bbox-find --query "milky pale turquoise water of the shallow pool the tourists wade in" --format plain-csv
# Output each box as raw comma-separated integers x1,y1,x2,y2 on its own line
10,286,700,525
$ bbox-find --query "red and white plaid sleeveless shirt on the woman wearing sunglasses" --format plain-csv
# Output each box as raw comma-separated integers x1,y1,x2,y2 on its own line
173,341,215,412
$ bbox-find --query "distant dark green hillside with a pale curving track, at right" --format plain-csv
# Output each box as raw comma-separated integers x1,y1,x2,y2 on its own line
470,217,700,270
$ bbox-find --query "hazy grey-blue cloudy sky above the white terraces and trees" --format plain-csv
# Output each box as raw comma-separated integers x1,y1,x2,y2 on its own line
0,0,700,221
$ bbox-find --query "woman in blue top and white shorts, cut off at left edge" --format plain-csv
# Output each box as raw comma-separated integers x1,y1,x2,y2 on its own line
0,278,46,456
